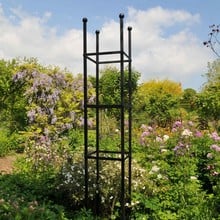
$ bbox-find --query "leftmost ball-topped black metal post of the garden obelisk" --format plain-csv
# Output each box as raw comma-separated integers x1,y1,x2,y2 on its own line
83,18,88,207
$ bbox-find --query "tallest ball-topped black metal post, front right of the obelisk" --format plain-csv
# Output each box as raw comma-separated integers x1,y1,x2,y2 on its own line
119,14,125,219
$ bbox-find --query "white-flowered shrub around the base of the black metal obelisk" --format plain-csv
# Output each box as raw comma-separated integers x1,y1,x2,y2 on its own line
58,152,149,213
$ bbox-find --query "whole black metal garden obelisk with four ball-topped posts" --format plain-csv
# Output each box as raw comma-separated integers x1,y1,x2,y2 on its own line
83,14,132,219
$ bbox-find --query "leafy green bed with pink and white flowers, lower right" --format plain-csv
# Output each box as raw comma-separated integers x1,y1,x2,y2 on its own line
133,121,220,220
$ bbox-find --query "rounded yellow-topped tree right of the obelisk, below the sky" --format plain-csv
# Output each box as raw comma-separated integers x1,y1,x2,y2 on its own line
134,80,182,127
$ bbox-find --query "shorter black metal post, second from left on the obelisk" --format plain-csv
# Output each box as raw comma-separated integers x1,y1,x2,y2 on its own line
96,30,100,215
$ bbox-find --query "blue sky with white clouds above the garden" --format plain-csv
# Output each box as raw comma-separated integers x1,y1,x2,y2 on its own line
0,0,217,90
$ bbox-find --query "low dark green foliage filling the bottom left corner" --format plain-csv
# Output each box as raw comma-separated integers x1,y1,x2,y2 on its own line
0,174,67,220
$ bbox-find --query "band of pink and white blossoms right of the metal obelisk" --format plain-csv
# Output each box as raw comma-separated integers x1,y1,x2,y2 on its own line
140,121,220,181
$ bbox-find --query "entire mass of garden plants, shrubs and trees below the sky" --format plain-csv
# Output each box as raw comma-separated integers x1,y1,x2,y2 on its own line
0,59,220,220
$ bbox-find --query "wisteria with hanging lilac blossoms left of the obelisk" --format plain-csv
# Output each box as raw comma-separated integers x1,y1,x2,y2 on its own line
13,69,93,170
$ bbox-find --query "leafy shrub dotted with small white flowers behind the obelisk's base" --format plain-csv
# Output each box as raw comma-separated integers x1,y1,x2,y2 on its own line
55,148,152,218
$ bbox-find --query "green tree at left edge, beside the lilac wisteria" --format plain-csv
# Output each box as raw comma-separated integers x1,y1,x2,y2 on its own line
0,59,26,133
